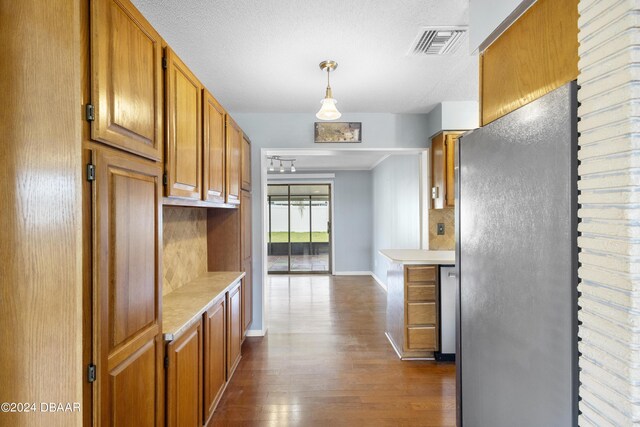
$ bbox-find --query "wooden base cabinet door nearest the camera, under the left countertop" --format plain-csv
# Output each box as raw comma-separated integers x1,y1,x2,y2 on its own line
167,321,202,427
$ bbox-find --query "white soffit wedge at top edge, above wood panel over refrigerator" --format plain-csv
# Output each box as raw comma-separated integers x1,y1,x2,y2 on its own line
469,0,536,52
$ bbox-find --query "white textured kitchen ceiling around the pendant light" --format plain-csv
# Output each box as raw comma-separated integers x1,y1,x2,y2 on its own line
133,0,478,113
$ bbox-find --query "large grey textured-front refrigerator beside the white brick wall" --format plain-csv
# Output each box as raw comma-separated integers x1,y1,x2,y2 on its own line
456,82,578,427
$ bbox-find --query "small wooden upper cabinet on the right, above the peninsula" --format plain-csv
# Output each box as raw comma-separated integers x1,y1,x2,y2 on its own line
431,131,462,209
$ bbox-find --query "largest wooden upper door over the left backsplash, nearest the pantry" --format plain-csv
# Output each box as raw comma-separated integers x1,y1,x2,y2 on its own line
165,48,202,200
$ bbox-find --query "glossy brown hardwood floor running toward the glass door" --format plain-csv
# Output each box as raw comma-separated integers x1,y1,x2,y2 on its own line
212,276,455,427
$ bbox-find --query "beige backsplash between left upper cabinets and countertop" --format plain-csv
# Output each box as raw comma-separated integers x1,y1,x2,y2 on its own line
162,206,207,295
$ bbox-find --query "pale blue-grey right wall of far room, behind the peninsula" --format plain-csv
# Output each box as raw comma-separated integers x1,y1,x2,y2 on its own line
371,154,420,284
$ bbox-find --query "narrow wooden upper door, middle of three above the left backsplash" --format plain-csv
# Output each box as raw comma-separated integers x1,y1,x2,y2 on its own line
202,90,226,203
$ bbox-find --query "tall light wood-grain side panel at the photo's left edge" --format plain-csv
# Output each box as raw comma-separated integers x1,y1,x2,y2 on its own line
0,0,82,427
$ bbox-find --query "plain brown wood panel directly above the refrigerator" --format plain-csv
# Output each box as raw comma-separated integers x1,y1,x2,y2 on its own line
480,0,578,125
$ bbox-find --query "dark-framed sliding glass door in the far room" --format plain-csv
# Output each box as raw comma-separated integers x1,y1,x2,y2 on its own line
267,184,331,274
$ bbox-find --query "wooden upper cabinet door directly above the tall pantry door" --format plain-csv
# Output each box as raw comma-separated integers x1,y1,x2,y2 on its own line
90,0,163,160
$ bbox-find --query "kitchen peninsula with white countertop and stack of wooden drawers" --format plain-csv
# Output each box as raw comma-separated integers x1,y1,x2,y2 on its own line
380,249,455,360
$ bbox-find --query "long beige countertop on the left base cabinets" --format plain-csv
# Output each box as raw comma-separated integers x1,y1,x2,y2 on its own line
162,271,245,341
